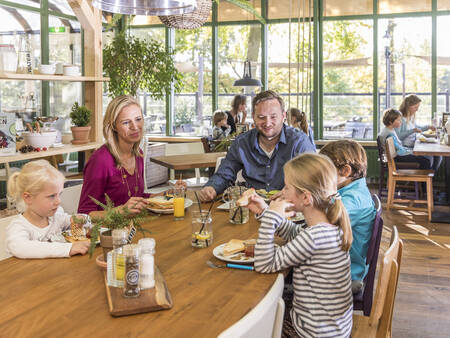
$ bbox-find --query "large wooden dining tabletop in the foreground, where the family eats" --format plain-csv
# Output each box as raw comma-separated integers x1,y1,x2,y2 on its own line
0,204,277,337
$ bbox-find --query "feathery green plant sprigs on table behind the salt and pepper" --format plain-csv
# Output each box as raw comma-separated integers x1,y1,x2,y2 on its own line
89,194,158,262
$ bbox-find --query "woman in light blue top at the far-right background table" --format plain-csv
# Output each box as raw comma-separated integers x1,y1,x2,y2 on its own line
395,94,442,170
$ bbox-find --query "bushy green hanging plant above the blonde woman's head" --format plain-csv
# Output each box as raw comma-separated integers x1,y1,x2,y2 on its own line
103,32,182,99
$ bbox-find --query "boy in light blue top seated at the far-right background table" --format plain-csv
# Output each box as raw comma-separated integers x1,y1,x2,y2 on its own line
379,108,431,169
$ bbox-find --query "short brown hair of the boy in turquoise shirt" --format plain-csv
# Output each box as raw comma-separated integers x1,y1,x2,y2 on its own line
320,140,367,181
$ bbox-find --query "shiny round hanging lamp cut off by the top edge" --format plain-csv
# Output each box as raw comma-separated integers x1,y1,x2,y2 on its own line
92,0,197,15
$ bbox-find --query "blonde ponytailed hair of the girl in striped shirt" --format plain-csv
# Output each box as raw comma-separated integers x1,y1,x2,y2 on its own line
284,153,353,251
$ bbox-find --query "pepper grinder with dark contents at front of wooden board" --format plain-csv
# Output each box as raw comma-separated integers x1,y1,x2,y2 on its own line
123,244,140,298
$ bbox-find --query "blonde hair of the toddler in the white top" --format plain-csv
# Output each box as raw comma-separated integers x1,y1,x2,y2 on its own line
8,160,65,212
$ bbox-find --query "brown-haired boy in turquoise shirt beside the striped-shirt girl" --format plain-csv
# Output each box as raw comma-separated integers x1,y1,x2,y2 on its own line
320,140,376,293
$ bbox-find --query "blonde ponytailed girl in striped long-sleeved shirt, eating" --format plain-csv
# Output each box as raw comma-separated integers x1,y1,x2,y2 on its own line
249,154,353,337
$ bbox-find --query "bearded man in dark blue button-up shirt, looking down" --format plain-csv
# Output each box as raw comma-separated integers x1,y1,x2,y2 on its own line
200,90,316,201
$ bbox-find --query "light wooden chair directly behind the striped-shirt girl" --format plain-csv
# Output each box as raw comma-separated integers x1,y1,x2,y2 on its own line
352,226,403,338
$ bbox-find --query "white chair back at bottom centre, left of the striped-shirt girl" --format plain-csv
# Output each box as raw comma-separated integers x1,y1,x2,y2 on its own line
218,274,284,338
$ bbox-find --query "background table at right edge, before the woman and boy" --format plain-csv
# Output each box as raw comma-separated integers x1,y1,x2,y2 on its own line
413,140,450,223
